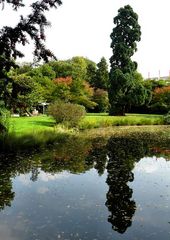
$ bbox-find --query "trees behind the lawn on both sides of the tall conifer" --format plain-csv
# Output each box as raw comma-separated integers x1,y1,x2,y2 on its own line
0,57,170,115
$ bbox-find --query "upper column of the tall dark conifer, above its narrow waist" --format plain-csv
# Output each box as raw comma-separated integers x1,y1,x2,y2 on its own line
110,5,141,74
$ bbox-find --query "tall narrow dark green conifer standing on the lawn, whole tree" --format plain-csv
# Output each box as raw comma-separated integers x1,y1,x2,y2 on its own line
109,5,143,115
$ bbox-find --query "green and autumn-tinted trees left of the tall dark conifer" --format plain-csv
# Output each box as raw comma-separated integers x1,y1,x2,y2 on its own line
0,57,109,114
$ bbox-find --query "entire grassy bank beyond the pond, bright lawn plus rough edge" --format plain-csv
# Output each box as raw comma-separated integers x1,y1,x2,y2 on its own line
0,114,170,153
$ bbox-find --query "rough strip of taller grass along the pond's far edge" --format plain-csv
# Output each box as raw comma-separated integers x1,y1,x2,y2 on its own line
0,125,170,154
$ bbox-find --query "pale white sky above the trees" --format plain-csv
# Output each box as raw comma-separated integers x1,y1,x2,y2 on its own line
0,0,170,78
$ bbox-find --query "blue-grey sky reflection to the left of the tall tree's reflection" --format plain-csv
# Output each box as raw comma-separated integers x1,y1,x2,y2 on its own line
0,170,112,240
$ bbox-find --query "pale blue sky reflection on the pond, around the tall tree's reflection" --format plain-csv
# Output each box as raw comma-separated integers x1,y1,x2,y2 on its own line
0,157,170,240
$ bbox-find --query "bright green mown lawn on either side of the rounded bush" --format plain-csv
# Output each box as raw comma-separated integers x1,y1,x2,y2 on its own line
10,113,163,135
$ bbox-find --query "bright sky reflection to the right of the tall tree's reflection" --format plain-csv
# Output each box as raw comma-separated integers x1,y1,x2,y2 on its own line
129,157,170,240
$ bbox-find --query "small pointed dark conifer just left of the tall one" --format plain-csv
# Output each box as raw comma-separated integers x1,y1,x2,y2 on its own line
94,57,109,90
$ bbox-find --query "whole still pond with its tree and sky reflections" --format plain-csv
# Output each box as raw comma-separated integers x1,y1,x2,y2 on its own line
0,137,170,240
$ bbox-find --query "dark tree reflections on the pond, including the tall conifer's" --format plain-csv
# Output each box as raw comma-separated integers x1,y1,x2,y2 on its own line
0,136,151,214
